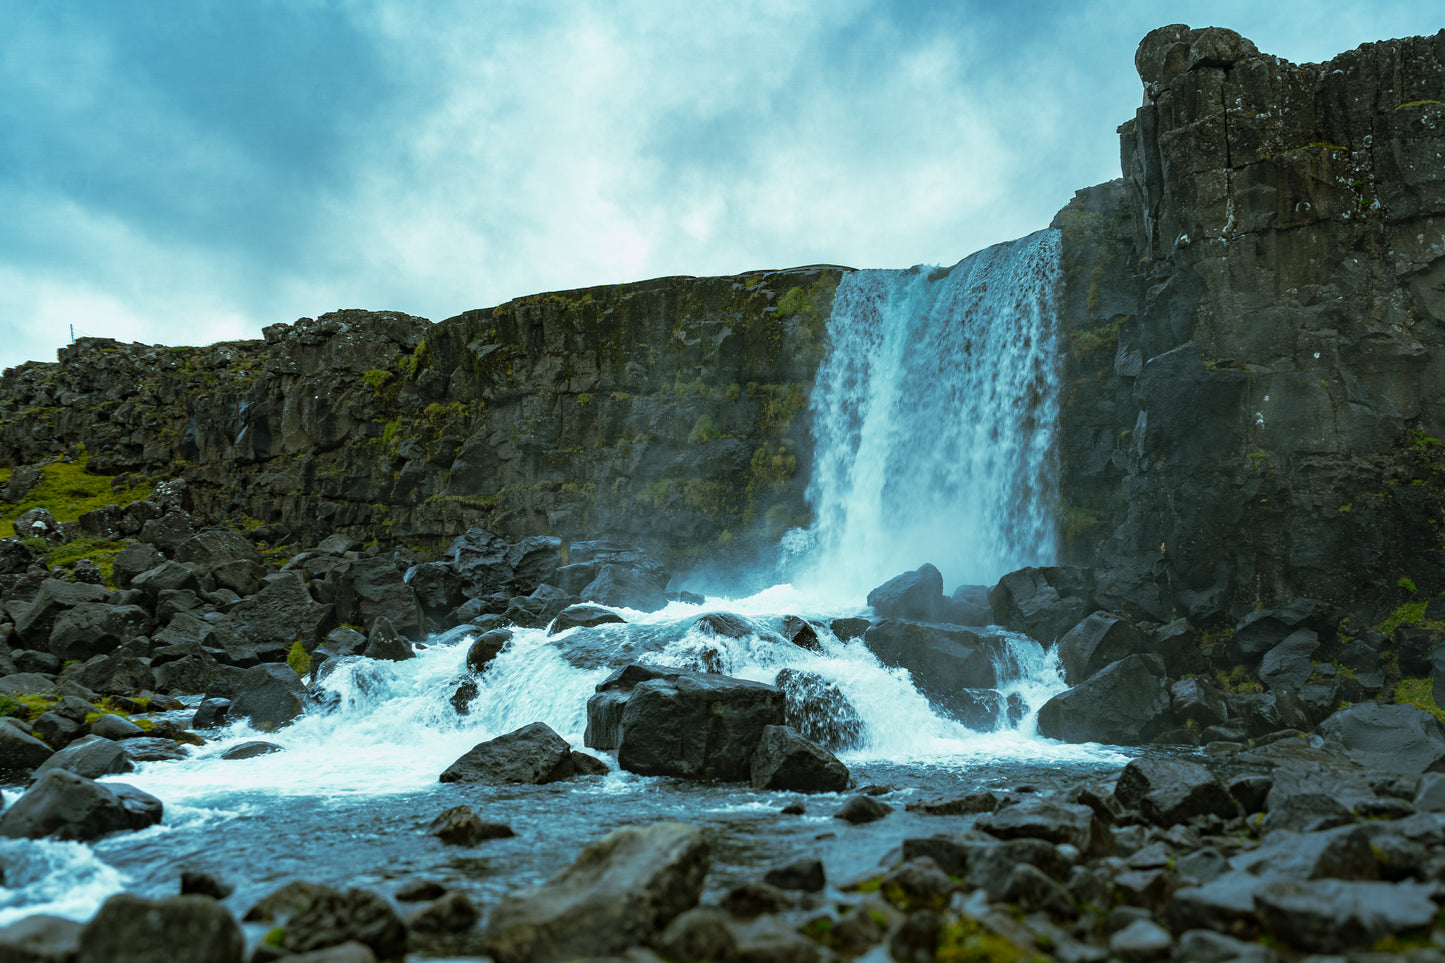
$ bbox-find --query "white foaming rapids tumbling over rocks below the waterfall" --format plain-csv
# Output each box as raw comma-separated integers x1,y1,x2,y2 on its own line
114,586,1113,820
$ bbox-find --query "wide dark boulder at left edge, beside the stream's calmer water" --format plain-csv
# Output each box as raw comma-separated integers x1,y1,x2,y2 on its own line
0,769,162,840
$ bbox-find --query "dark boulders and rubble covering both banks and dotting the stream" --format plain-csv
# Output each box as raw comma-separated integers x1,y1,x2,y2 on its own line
0,468,1445,962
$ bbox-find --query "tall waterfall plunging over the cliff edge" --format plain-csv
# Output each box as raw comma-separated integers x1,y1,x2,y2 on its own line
785,230,1062,599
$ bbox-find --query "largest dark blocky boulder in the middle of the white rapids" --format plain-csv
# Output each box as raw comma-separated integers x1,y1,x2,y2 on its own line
617,672,786,779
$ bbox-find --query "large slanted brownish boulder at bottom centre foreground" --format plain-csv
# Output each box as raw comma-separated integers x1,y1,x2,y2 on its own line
484,823,708,963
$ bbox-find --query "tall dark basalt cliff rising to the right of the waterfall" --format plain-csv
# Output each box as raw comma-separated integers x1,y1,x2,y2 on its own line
1056,26,1445,620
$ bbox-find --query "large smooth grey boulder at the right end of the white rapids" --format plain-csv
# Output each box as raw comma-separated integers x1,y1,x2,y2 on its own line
1039,655,1170,746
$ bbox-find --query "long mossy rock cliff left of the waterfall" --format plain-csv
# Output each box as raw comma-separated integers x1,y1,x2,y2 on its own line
0,268,842,561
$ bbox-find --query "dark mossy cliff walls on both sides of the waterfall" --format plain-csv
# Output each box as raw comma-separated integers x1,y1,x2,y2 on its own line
0,26,1445,622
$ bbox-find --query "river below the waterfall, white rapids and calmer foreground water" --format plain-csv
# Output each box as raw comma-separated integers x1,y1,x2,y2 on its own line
0,587,1124,924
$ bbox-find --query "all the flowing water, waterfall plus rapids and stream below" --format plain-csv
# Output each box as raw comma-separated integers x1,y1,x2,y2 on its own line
0,225,1123,925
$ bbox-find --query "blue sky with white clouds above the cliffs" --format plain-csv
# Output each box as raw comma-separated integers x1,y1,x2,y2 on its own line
0,0,1442,367
